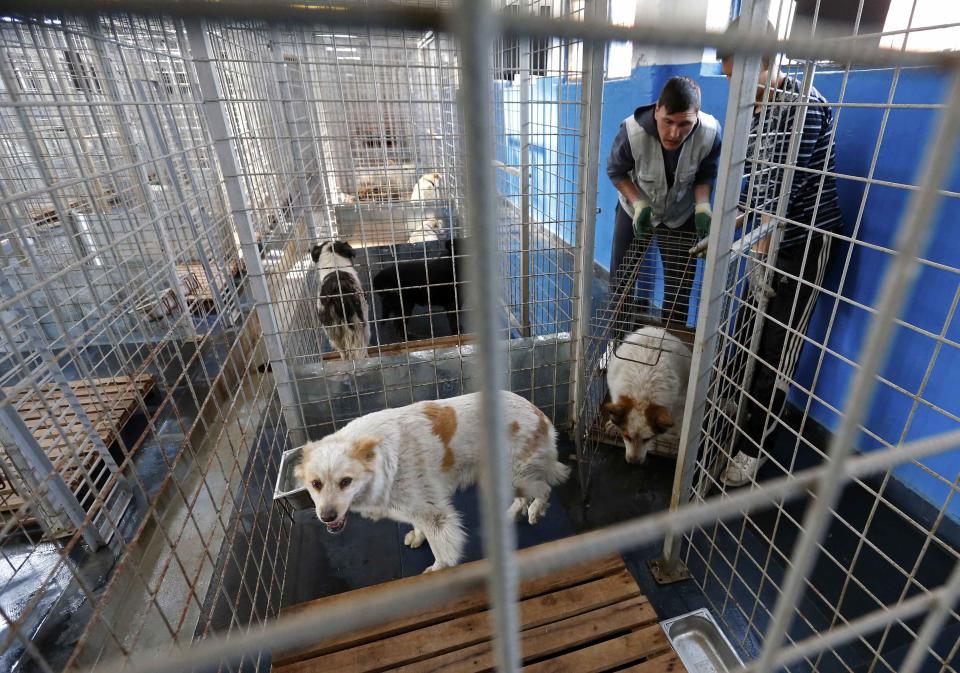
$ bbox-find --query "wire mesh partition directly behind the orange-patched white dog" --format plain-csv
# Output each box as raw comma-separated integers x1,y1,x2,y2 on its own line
202,4,590,444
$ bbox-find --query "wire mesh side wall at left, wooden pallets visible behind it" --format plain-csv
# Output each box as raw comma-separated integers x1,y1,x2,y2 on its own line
0,12,291,671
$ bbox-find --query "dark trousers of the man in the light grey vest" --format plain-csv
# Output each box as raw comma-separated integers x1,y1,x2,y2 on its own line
610,203,697,332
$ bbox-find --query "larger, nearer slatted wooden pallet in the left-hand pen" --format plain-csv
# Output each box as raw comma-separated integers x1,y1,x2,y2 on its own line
0,374,153,526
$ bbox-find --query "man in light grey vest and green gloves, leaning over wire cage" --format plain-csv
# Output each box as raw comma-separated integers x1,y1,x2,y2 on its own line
607,77,720,335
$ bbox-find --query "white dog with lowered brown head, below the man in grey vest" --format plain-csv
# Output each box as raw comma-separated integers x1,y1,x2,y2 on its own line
603,327,690,464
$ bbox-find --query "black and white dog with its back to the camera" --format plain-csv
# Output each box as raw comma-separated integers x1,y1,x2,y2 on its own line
310,241,370,360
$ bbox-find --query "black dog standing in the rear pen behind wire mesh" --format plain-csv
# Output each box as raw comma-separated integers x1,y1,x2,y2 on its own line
373,239,467,340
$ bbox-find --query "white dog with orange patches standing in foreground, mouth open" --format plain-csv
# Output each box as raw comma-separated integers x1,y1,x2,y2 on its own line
296,391,570,572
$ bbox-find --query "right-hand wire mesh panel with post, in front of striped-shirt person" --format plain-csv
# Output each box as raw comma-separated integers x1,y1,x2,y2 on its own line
665,2,960,671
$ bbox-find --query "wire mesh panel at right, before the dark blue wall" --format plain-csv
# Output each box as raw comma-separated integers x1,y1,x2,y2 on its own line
675,13,957,671
